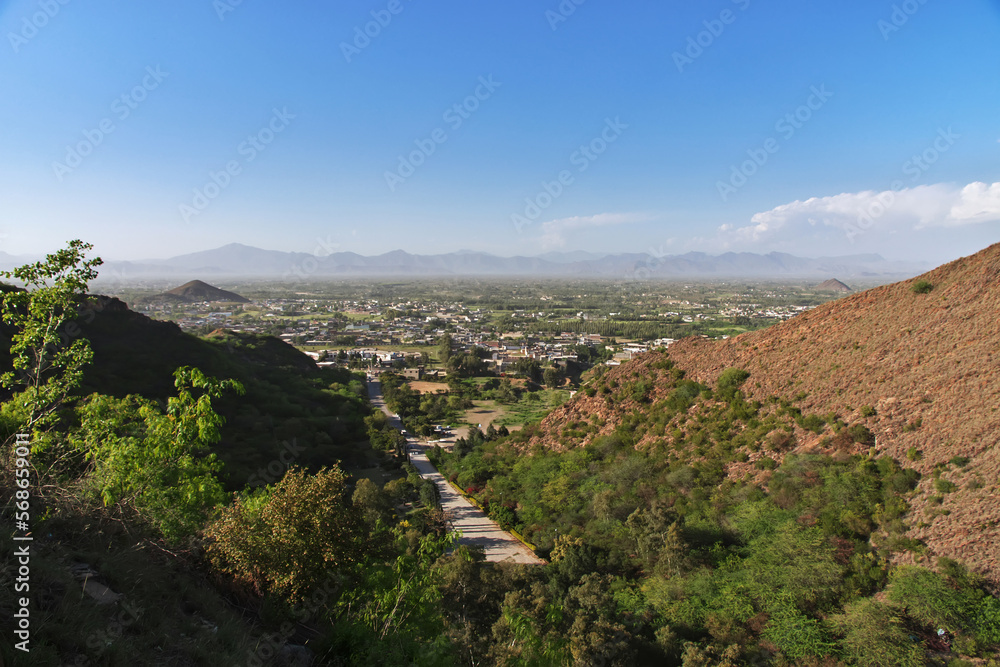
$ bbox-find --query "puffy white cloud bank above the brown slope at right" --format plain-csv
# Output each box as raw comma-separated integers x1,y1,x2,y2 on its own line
719,183,1000,243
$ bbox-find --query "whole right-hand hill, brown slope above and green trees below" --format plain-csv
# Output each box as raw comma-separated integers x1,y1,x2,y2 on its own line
437,246,1000,665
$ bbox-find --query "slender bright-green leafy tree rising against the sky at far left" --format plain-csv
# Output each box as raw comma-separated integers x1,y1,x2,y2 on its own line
0,240,103,429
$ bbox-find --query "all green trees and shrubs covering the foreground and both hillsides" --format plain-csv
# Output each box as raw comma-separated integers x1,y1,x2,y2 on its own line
0,241,1000,667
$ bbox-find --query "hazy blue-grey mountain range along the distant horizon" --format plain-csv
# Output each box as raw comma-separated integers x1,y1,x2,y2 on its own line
94,243,929,281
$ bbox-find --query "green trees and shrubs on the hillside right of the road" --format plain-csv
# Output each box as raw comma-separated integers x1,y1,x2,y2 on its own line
436,360,1000,665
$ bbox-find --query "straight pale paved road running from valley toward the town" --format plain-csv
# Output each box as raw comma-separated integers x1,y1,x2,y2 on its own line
368,380,545,565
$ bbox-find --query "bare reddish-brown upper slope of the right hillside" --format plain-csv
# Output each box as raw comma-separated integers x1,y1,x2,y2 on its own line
670,244,1000,579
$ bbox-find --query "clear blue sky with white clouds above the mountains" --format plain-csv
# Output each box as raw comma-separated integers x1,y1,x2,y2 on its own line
0,0,1000,261
